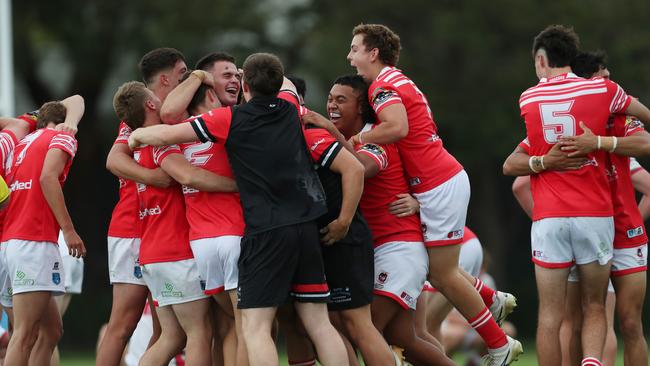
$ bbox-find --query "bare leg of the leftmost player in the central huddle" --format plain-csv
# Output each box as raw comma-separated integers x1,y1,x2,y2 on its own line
96,283,149,366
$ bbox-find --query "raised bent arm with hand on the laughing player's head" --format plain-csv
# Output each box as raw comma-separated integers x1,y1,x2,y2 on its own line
160,70,214,125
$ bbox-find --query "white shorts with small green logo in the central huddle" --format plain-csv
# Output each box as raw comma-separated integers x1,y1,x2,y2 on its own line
142,258,207,306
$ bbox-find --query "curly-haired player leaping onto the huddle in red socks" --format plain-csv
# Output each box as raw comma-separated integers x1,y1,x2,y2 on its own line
347,24,522,365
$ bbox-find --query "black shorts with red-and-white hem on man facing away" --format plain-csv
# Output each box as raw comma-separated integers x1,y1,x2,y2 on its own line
237,222,330,309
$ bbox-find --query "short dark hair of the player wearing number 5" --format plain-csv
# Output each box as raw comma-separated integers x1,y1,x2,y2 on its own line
533,24,580,67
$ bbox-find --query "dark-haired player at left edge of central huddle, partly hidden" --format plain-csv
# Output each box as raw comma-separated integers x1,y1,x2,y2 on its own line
96,48,187,366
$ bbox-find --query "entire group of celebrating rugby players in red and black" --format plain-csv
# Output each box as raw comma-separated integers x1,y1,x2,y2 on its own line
0,24,650,366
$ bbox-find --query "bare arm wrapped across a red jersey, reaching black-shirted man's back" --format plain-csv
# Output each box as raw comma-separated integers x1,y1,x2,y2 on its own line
158,151,237,192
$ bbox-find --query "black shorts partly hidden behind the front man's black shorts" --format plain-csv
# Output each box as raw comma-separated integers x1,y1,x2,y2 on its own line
323,234,375,311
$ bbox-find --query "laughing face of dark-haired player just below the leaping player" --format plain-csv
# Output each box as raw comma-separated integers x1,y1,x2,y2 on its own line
327,84,363,137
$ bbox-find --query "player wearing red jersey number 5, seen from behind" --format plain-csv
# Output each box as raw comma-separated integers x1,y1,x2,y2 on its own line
504,26,650,365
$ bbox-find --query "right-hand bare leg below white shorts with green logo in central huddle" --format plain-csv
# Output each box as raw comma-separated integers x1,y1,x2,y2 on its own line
171,298,212,366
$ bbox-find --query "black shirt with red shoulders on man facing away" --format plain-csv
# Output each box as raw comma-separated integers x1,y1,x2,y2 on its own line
190,93,326,235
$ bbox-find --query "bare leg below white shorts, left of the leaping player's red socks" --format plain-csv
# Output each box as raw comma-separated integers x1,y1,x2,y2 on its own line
371,296,453,365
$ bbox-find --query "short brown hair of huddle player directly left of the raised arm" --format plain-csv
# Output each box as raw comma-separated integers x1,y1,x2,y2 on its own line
113,81,149,130
